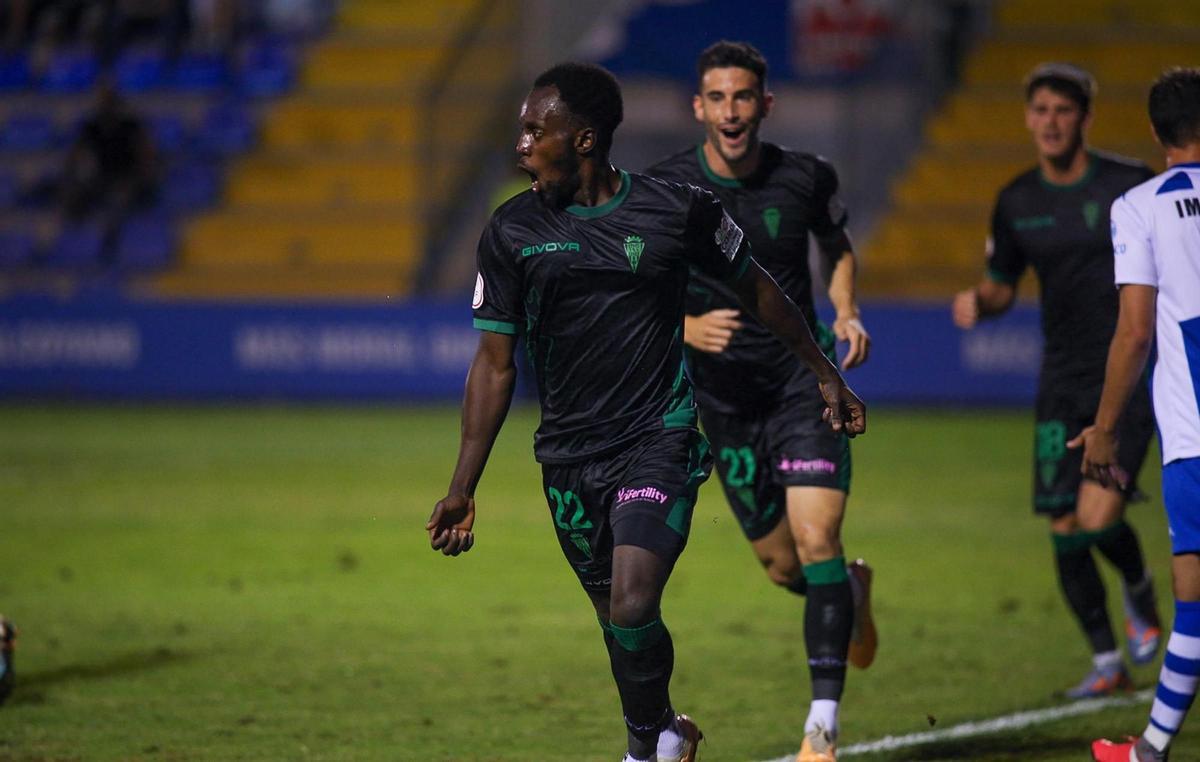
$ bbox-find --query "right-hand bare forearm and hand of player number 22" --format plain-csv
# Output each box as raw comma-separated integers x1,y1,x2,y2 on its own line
733,259,866,437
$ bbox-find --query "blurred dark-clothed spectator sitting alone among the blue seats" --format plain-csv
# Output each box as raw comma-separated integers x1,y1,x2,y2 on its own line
59,82,158,259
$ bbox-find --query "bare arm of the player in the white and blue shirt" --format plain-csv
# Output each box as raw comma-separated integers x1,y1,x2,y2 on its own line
1067,284,1158,487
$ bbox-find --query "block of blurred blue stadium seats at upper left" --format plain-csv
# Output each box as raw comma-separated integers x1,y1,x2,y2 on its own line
0,0,324,292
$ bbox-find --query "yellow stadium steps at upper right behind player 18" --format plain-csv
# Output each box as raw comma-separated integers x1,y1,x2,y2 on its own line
860,0,1200,300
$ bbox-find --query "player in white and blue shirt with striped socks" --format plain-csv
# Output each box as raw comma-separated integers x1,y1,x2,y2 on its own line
1072,68,1200,762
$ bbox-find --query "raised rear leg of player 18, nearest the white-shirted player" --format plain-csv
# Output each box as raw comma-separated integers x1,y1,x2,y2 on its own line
1076,480,1162,665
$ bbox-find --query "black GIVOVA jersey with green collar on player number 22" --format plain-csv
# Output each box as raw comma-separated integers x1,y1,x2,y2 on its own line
473,172,750,463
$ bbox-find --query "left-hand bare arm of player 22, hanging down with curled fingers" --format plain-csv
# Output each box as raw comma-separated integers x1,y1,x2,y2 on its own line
425,331,517,556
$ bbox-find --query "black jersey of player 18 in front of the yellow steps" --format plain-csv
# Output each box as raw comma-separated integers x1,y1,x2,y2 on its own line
988,151,1154,389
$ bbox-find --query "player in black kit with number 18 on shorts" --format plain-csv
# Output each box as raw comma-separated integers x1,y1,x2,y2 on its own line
953,64,1160,698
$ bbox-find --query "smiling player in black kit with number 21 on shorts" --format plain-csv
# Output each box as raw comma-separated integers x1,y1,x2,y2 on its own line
647,41,877,762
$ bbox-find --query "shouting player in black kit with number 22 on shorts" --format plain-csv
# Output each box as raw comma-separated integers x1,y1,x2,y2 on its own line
426,64,866,762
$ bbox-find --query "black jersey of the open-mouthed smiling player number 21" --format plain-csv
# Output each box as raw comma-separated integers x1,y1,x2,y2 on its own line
647,142,850,413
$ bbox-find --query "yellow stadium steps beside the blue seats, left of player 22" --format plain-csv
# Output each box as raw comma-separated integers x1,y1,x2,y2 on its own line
140,0,516,299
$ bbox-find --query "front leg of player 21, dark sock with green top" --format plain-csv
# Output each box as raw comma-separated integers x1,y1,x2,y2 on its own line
787,487,854,760
